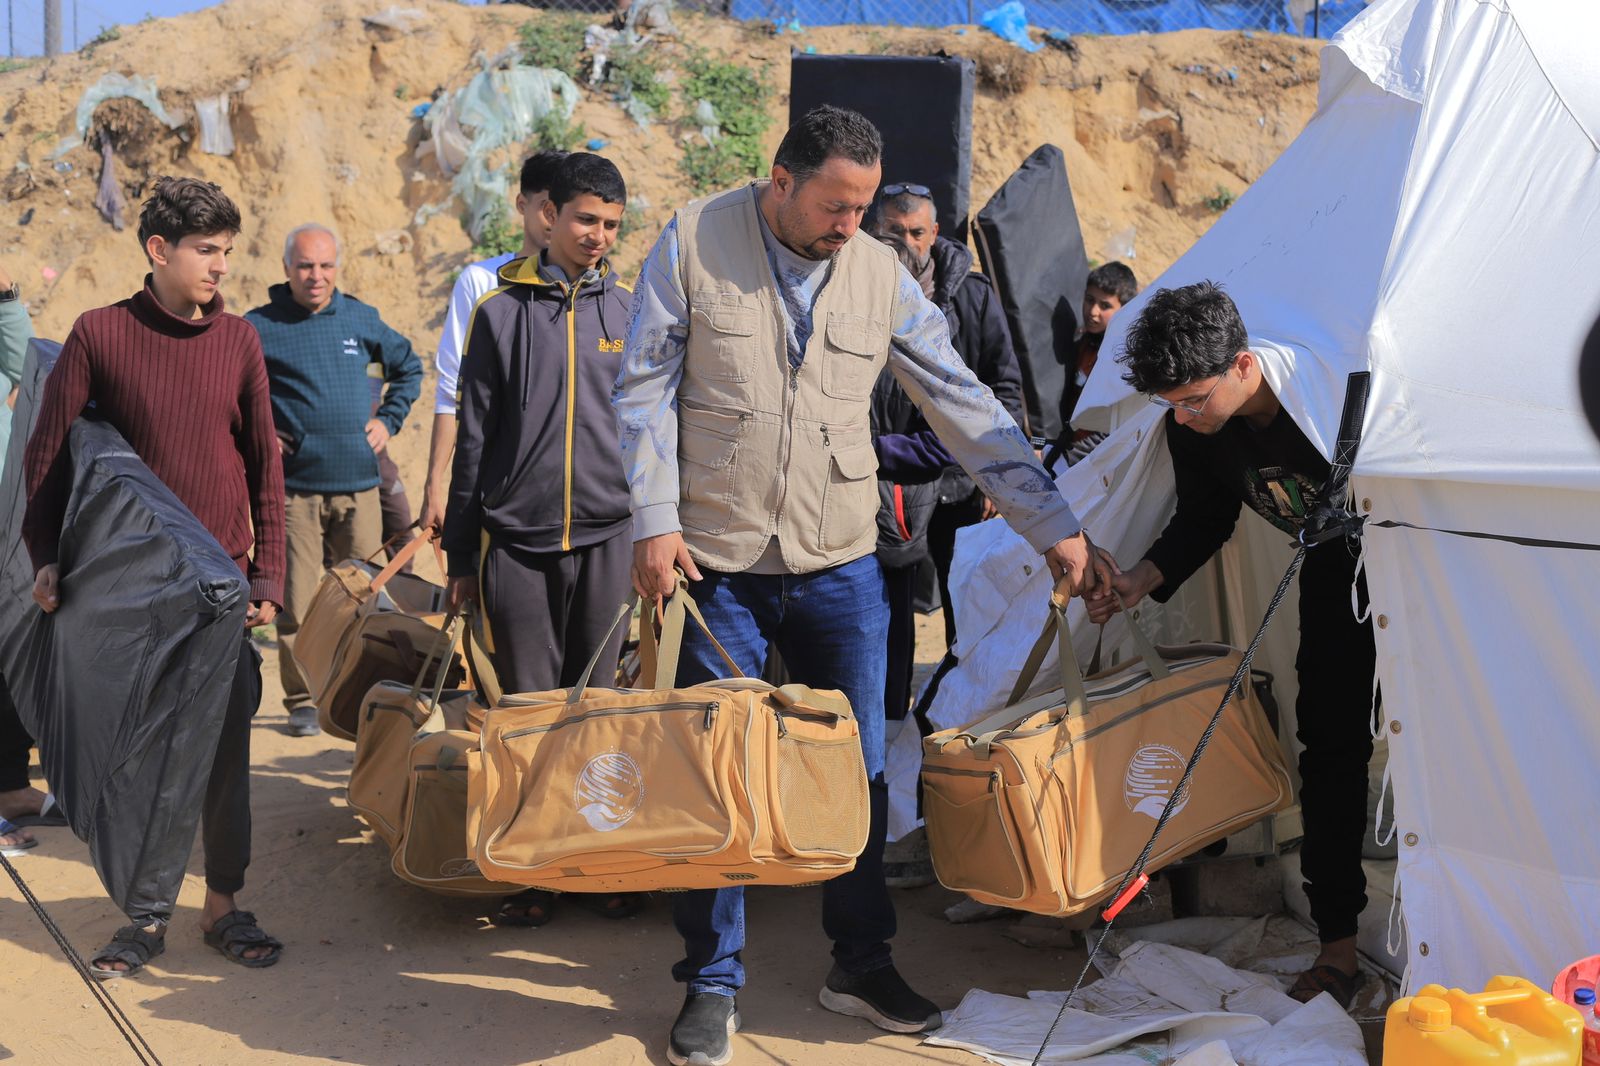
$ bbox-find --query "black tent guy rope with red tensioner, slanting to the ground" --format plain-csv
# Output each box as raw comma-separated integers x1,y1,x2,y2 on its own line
1032,371,1371,1066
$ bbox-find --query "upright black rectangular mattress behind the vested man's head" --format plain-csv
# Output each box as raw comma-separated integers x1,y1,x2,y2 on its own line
789,53,976,240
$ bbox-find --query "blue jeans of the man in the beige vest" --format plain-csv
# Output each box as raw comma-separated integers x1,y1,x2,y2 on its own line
672,555,894,996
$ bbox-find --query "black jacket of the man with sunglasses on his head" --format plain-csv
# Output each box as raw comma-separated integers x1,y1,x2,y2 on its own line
933,237,1022,503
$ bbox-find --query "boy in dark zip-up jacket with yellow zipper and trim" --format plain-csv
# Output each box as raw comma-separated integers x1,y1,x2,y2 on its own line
443,152,638,925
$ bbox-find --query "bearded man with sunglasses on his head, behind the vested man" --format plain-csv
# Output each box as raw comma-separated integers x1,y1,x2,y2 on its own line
877,181,1022,643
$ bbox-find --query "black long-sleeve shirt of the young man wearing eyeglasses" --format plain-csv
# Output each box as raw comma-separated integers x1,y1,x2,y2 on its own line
1144,400,1328,603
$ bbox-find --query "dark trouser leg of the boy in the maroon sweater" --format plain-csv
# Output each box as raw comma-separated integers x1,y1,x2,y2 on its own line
198,634,261,917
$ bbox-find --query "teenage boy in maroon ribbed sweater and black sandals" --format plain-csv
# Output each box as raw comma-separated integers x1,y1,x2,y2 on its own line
22,178,285,978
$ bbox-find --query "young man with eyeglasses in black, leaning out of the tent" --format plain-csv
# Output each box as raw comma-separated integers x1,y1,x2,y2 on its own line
1088,282,1374,1007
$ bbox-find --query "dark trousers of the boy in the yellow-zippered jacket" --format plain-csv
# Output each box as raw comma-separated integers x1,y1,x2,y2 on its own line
480,523,634,693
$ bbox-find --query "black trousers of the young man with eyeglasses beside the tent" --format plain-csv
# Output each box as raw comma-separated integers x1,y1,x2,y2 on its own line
1294,543,1376,943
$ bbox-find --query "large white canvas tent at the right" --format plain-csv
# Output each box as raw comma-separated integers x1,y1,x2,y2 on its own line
890,0,1600,988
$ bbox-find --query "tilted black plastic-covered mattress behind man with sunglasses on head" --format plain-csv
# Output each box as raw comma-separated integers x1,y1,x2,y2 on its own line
973,144,1090,442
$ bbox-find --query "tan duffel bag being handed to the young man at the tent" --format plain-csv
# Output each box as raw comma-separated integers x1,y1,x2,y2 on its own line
922,582,1291,916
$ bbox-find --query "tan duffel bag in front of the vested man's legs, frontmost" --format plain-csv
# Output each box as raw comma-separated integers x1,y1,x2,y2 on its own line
467,579,867,892
